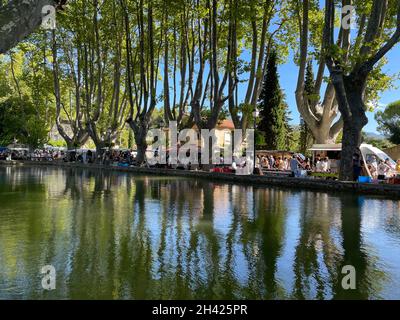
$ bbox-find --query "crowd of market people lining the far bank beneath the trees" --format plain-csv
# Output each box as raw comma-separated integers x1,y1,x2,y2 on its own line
0,149,400,180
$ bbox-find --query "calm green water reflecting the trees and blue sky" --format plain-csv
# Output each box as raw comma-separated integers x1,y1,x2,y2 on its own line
0,166,400,299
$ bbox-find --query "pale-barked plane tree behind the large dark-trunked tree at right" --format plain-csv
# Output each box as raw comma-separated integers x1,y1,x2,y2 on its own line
288,0,393,147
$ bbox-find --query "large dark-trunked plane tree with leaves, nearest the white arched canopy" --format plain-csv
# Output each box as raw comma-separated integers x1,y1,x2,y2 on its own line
323,0,400,181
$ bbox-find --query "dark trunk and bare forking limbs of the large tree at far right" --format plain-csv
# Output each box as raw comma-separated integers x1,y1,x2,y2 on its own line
322,0,400,181
